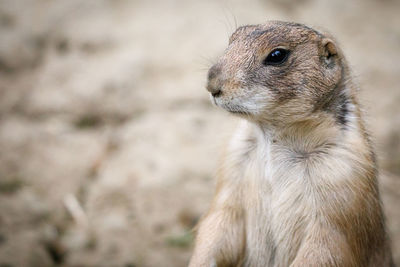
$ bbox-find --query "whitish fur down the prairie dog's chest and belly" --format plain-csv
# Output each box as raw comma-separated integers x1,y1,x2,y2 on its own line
225,122,362,266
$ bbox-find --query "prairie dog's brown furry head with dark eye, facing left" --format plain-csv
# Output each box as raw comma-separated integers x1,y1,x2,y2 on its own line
207,21,344,123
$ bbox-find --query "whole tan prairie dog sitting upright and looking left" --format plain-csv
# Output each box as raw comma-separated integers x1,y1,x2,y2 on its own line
189,21,393,267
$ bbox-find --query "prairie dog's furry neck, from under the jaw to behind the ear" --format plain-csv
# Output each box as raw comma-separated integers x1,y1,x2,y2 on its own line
254,77,363,153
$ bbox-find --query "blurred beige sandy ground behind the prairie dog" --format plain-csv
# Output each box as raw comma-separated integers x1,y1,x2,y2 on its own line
0,0,400,267
